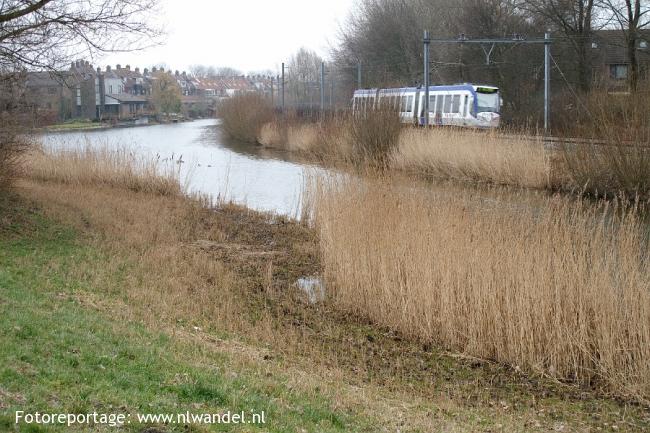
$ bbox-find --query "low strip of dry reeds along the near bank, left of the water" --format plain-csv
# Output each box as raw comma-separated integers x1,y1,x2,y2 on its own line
26,146,183,196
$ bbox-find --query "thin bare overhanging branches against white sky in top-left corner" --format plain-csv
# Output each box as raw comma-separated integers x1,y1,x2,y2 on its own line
0,0,162,71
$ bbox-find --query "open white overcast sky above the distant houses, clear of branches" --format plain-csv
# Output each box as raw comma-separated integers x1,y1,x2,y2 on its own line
98,0,356,72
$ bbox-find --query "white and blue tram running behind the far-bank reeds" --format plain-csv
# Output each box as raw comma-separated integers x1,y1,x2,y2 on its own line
352,84,502,128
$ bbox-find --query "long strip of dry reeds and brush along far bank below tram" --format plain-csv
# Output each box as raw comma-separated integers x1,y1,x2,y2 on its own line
259,117,567,188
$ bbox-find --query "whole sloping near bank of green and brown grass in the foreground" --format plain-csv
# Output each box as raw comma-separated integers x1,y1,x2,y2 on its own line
0,147,650,432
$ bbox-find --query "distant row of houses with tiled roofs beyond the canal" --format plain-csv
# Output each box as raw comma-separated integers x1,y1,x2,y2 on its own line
22,60,273,124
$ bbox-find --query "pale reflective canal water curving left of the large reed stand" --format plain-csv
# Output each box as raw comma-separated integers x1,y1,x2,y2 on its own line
42,119,325,217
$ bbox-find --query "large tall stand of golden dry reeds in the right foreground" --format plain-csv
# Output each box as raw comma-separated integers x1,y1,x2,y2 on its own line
311,175,650,403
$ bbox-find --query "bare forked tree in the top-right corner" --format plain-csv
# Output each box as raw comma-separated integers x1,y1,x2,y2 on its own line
601,0,650,90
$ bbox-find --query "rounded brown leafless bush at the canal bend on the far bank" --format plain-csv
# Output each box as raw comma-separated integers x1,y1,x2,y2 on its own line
217,93,273,143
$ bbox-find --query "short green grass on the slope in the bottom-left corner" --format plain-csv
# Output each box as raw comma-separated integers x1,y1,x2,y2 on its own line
0,197,374,432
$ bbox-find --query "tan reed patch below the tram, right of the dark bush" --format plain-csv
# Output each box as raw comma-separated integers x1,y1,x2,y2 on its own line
392,128,558,188
